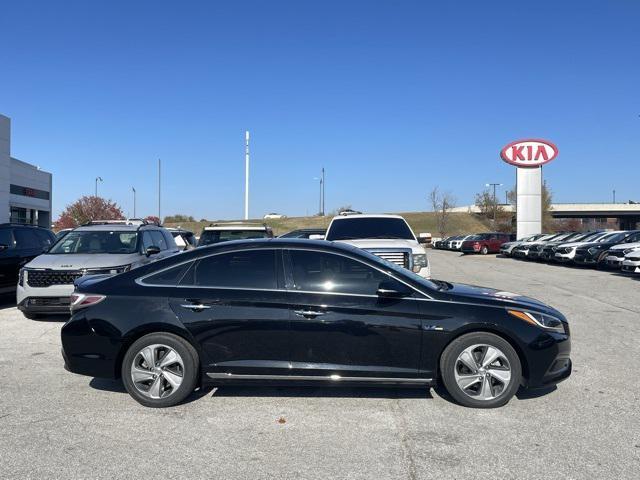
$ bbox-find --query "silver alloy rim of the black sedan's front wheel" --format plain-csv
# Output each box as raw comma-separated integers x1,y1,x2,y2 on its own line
454,344,511,401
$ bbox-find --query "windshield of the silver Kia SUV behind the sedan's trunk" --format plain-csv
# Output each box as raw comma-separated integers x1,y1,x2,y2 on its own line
48,230,138,254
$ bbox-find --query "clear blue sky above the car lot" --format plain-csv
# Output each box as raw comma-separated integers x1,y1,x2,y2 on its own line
0,0,640,219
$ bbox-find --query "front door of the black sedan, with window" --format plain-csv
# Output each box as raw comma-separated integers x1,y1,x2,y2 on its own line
285,250,421,377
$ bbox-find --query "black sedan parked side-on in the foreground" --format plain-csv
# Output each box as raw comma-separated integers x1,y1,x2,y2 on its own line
62,239,571,408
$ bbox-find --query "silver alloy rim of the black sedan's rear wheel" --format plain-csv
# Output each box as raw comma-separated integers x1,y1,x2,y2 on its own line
131,344,184,399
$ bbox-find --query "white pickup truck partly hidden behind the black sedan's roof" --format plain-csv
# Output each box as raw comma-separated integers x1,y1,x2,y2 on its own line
325,215,431,278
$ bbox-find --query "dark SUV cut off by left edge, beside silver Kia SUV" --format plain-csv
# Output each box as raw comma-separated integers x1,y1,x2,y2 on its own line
0,223,56,294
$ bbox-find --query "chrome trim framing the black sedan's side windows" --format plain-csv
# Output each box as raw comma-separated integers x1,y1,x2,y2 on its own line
134,246,433,300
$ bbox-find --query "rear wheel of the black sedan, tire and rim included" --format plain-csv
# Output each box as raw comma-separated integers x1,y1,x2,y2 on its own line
121,332,200,408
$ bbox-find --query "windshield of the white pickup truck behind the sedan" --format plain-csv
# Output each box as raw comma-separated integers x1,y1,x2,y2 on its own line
326,217,415,241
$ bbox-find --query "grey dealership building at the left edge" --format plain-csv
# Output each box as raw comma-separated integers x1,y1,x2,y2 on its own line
0,115,51,227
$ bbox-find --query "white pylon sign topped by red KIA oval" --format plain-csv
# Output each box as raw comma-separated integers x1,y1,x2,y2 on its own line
500,138,558,238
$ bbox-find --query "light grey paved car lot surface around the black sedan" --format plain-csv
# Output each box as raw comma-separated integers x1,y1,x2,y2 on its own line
0,250,640,478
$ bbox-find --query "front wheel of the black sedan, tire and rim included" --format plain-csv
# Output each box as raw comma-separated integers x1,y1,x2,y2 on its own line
440,332,522,408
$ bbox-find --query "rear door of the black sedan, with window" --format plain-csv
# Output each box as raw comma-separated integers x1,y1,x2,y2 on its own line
169,249,290,375
